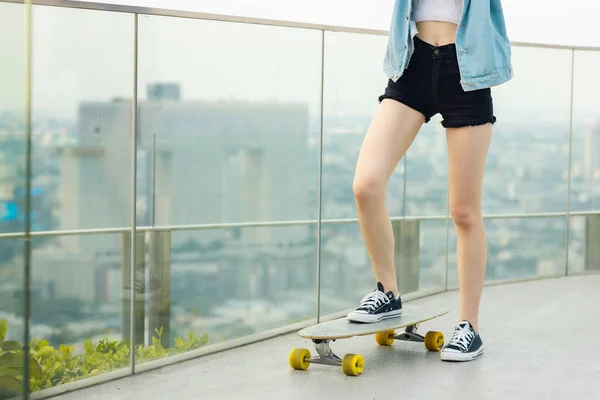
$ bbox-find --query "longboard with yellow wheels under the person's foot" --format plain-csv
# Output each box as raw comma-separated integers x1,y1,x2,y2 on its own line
288,305,448,376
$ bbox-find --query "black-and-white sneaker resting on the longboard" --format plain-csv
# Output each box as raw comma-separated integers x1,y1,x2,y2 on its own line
347,282,402,322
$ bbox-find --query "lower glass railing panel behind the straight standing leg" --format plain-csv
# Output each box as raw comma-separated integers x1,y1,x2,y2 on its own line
448,217,565,287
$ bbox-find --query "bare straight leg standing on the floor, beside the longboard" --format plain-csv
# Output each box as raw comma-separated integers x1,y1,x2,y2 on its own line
446,124,492,332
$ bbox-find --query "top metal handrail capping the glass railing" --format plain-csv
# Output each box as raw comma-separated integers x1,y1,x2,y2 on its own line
0,0,600,51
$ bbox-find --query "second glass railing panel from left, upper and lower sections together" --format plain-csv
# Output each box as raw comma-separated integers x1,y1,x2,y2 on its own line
10,3,134,391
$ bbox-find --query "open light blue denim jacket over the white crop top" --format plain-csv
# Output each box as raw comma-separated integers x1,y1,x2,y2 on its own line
383,0,513,92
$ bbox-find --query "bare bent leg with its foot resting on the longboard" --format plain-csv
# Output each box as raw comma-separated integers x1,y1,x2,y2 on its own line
353,99,425,296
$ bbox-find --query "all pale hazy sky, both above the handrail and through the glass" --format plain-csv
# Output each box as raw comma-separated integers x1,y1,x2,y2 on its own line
0,0,600,120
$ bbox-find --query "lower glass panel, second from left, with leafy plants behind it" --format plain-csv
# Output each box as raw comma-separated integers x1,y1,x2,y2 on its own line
30,232,131,391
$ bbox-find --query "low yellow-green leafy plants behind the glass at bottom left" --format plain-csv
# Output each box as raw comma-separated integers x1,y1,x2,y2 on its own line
0,320,208,399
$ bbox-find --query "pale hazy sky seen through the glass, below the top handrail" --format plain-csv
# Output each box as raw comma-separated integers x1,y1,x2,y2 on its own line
0,3,600,121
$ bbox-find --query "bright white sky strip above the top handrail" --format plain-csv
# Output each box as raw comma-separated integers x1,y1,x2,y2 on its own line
84,0,600,46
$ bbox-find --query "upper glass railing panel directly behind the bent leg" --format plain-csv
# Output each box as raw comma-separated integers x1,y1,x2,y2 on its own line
322,32,396,219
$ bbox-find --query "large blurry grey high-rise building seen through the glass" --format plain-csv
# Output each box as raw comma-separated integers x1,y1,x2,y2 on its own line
59,85,310,251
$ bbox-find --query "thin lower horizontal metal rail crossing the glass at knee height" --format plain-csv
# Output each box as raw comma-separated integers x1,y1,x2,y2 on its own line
0,210,600,239
